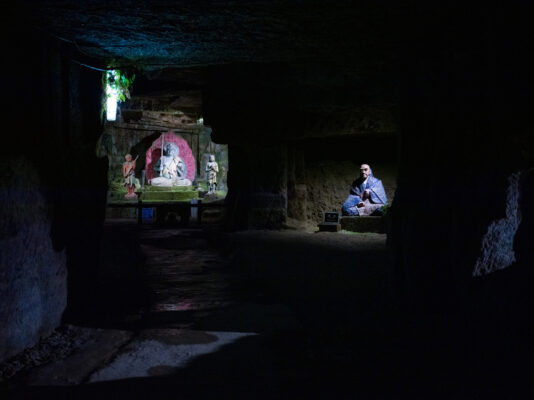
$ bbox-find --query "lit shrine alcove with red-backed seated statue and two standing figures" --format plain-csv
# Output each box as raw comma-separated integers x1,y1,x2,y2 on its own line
97,77,228,220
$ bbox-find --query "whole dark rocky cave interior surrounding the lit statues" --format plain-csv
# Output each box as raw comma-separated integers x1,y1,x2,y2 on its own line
0,0,534,398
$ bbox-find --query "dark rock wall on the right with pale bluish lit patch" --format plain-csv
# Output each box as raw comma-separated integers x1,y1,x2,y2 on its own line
382,2,534,390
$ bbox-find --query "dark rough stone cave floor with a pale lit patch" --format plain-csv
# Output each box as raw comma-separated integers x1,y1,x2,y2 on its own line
4,222,410,398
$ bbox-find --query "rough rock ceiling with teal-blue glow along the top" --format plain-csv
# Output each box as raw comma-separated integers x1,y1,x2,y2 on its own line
29,0,402,69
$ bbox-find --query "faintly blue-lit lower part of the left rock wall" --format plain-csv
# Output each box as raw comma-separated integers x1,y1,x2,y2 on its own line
0,157,67,361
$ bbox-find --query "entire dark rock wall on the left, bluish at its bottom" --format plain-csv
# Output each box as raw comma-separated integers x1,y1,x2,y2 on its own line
0,26,107,359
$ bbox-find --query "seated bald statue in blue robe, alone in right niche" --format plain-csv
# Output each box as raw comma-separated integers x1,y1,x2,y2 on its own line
342,164,388,215
